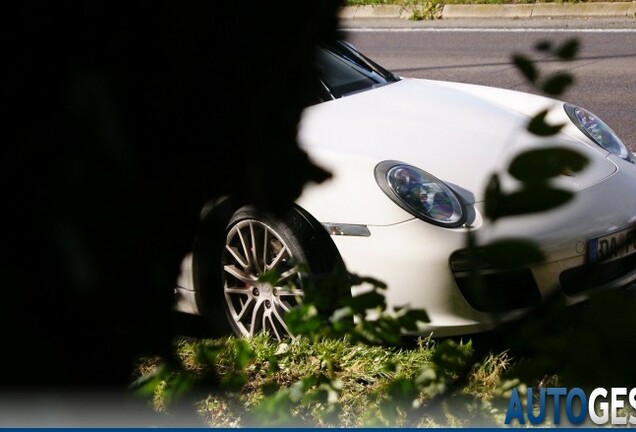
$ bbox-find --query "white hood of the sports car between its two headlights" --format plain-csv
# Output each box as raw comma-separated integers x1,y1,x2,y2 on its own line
299,79,616,208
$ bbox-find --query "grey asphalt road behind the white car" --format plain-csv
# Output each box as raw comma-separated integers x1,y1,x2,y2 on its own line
343,20,636,151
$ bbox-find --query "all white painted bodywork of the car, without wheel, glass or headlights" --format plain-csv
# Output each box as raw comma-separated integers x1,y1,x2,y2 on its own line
176,45,636,336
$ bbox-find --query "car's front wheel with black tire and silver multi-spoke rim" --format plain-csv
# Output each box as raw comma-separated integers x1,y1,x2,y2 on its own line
193,200,344,339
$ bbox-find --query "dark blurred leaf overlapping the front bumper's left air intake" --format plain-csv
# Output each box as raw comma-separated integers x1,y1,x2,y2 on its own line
478,238,545,270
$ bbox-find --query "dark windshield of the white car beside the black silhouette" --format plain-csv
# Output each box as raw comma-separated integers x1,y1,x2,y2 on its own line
316,42,397,100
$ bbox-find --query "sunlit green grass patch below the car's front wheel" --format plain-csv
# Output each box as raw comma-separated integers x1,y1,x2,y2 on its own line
134,336,512,427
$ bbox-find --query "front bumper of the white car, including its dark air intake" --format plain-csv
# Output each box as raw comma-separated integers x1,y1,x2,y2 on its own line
332,159,636,336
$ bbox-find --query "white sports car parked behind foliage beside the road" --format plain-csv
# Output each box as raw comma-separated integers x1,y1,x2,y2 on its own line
177,43,636,338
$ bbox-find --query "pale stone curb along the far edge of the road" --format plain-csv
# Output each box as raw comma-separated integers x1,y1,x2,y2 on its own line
339,1,636,19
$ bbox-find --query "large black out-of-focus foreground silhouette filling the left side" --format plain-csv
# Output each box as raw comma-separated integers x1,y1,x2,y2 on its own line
0,0,340,414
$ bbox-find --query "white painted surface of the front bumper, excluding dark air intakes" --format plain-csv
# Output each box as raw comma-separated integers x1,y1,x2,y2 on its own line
320,160,636,336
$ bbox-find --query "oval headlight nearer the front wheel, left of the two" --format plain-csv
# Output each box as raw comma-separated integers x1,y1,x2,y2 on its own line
375,161,464,227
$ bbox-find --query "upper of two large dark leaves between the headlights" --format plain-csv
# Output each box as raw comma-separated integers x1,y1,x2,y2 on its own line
508,147,588,183
